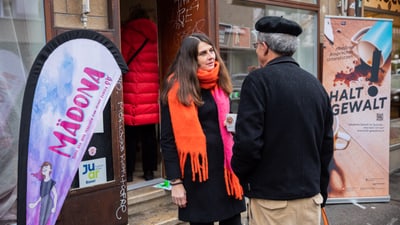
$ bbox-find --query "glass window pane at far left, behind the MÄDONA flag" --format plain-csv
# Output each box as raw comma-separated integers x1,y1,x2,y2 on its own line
0,0,45,221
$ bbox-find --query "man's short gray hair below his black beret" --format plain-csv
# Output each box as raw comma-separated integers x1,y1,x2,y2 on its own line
257,32,299,56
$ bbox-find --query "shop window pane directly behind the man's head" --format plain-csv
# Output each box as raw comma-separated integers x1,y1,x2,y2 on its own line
218,0,318,112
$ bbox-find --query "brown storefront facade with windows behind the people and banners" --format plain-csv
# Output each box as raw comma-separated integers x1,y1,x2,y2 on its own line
0,0,400,224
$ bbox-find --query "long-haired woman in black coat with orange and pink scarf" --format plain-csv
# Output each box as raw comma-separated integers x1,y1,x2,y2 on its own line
160,33,245,225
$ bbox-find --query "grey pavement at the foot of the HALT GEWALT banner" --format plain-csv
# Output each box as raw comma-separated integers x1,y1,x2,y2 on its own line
326,168,400,225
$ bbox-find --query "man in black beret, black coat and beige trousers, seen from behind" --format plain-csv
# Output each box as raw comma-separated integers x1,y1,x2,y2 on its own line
231,16,333,225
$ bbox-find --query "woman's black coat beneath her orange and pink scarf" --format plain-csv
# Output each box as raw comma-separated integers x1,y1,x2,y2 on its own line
160,90,246,223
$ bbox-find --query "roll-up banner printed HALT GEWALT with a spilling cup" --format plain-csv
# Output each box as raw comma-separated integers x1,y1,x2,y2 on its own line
322,16,392,203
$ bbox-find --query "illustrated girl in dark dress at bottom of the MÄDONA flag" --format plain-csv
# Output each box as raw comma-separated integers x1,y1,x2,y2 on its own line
29,162,57,225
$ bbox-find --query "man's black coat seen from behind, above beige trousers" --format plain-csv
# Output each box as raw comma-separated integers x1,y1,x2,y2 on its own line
231,57,333,205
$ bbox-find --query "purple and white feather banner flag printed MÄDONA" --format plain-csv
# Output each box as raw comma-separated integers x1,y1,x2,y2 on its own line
17,30,128,225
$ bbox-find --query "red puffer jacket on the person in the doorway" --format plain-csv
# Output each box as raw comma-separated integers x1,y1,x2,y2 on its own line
121,19,159,126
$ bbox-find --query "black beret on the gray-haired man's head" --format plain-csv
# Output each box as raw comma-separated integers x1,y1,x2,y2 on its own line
255,16,303,36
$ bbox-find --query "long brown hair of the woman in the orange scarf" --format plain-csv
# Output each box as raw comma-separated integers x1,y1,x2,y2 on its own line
160,33,232,106
